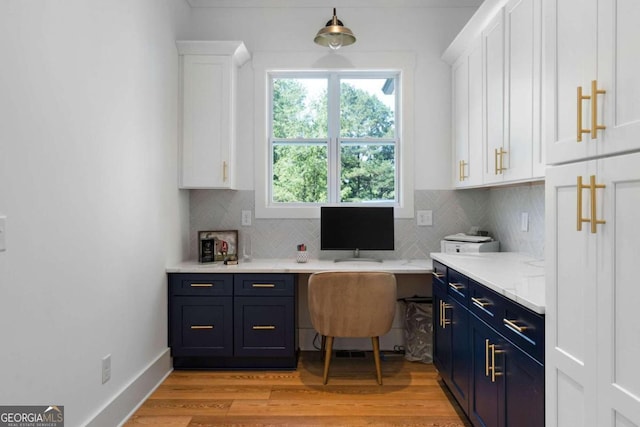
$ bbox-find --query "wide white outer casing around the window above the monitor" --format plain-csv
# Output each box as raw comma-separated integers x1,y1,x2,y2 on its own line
253,52,415,219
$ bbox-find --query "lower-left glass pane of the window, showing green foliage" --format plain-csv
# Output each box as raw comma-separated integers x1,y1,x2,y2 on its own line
272,142,328,203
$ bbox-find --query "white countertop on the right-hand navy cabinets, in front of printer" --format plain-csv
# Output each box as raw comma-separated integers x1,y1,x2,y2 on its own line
431,252,545,314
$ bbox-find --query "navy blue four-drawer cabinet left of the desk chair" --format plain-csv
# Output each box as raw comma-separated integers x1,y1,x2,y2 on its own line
168,273,297,369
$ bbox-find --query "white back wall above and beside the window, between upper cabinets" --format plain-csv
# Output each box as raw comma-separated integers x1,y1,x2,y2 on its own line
180,7,476,190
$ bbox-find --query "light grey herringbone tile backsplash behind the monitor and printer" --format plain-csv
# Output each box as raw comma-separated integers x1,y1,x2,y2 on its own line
190,184,544,259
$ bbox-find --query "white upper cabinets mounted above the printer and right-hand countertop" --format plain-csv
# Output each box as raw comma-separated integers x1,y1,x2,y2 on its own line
443,0,545,187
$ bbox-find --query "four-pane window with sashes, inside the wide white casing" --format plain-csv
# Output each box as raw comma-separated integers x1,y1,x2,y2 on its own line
269,71,400,206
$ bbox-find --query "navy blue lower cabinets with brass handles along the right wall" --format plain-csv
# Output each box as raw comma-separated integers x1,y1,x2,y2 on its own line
432,261,544,427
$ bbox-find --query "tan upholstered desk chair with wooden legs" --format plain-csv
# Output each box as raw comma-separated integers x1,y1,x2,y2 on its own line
309,271,396,384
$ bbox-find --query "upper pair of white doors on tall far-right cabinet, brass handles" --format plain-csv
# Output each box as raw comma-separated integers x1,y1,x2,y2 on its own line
543,0,640,164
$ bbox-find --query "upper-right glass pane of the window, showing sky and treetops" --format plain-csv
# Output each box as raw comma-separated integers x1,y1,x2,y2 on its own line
340,78,396,138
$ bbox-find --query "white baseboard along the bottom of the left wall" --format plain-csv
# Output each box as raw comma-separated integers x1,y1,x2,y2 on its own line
85,348,173,427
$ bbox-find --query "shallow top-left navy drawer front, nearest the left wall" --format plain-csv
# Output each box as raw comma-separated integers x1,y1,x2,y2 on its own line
169,273,233,296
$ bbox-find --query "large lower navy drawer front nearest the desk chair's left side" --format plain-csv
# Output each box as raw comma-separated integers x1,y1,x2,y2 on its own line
234,297,295,357
